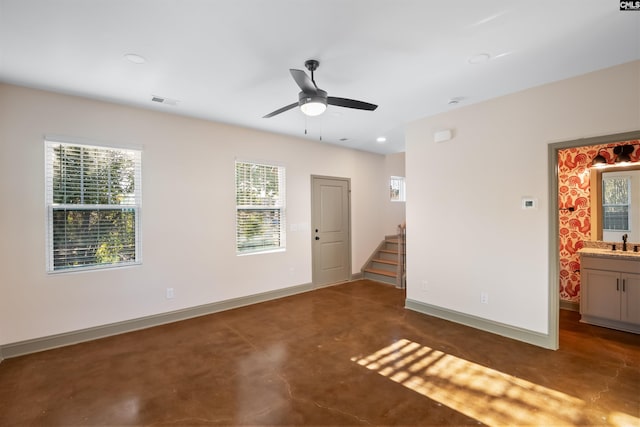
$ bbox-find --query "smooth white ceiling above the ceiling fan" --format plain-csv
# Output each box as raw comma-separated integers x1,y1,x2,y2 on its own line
0,0,640,154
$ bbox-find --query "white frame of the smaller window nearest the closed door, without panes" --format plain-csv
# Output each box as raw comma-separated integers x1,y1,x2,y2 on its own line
234,159,287,256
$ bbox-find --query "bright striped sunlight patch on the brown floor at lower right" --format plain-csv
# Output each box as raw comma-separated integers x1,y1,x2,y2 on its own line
351,339,640,426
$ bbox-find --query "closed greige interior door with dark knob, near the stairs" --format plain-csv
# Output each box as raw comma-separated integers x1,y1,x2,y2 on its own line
311,176,351,286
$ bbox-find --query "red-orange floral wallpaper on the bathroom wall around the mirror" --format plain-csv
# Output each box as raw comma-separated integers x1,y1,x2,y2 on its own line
558,140,640,302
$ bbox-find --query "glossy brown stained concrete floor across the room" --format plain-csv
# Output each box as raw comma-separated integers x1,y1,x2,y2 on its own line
0,280,640,426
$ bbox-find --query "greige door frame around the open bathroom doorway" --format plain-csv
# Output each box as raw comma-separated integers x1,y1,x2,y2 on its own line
547,130,640,350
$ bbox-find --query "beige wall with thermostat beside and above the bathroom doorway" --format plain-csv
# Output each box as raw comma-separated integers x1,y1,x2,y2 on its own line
406,61,640,334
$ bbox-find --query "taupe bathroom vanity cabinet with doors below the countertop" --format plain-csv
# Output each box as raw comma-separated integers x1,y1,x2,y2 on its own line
580,252,640,334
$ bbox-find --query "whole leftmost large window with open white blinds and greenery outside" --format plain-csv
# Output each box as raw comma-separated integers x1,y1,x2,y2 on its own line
45,141,141,272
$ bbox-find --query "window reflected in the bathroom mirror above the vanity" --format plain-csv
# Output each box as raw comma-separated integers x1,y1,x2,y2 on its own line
602,176,631,231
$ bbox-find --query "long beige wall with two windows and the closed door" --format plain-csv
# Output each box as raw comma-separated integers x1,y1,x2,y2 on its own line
0,84,397,344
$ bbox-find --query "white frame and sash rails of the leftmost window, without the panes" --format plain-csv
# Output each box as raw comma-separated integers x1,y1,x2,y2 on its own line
44,137,142,274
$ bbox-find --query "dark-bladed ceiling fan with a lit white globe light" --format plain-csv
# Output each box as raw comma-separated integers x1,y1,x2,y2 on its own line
263,59,378,119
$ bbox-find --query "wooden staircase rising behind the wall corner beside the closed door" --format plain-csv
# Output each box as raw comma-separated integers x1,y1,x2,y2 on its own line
362,226,406,288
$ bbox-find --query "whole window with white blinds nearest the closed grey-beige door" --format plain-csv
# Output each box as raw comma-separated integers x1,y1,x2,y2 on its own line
236,161,285,254
